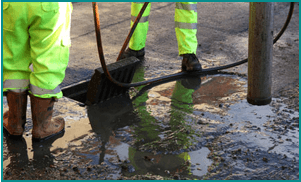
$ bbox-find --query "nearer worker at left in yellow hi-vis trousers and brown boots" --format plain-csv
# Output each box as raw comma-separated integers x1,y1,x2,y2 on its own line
3,2,72,140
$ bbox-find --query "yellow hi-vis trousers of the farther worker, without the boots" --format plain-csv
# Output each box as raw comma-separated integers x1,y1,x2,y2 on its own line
129,2,198,55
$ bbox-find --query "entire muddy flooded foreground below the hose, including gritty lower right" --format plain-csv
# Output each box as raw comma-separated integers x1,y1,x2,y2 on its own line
3,71,299,179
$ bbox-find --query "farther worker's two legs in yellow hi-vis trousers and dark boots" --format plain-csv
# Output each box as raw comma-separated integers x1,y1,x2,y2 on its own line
121,2,202,71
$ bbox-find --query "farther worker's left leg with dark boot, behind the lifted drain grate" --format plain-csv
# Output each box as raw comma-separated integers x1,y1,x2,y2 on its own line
121,2,151,59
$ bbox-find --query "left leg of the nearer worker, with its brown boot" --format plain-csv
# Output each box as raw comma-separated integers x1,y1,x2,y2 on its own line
3,2,31,136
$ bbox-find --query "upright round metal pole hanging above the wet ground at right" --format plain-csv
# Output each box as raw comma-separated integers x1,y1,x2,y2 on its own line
247,2,274,105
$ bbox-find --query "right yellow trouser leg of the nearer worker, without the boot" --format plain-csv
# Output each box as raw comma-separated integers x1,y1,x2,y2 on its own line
29,2,72,98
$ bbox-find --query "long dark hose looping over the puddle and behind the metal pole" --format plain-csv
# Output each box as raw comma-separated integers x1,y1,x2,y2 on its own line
93,2,294,88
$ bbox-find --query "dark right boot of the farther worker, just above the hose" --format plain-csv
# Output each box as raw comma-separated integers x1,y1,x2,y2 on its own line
182,54,202,71
